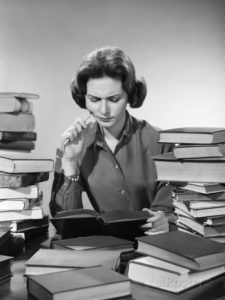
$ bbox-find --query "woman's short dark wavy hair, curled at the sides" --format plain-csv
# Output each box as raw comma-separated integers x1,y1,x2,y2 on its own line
70,47,147,108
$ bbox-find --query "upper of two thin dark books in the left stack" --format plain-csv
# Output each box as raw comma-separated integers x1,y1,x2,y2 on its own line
0,131,37,142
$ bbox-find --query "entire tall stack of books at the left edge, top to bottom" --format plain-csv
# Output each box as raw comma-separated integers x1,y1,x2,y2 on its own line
0,92,53,246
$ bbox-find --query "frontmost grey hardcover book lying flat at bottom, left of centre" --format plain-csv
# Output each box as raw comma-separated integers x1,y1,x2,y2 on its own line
27,266,131,300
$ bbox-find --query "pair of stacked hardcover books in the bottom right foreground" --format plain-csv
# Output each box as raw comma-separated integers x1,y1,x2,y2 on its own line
127,230,225,299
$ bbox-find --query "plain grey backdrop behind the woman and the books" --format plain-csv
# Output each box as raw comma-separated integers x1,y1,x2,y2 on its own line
0,0,225,212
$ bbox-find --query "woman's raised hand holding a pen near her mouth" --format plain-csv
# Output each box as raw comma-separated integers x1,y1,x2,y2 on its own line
60,119,95,162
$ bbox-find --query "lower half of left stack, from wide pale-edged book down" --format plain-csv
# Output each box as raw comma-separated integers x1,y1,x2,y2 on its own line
0,153,54,241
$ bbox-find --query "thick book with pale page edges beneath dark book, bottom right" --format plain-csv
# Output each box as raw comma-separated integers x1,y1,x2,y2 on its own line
127,256,225,293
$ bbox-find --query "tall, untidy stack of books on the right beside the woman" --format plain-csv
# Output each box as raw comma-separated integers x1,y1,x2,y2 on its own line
154,127,225,243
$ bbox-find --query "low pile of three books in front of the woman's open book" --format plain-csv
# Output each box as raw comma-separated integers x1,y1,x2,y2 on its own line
25,235,134,300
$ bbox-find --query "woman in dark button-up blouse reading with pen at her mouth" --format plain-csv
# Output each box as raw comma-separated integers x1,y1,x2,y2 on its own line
50,47,171,234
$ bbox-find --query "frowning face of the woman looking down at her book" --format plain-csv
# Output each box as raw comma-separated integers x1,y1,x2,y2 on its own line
85,77,127,135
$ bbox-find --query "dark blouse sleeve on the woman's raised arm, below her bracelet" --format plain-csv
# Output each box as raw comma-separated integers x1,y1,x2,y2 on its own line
49,149,84,216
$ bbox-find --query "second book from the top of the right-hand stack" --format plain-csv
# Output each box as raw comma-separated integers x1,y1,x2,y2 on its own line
173,143,225,158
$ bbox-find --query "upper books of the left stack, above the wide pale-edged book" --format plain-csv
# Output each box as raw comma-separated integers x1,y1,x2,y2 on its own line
0,92,39,152
